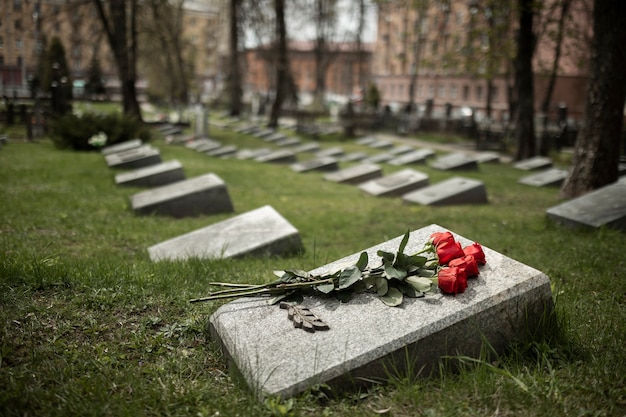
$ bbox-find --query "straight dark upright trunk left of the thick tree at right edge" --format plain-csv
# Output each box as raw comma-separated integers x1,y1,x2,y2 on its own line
515,0,537,160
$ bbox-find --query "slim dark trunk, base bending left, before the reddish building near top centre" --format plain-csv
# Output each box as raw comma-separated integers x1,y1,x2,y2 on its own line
268,0,289,128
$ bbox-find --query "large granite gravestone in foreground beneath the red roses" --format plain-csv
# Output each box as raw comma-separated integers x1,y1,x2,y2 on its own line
209,225,553,398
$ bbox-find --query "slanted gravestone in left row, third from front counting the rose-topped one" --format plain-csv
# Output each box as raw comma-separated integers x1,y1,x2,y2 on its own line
130,173,234,217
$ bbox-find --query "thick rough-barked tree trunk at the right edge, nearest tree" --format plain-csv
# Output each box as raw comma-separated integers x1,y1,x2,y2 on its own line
561,0,626,198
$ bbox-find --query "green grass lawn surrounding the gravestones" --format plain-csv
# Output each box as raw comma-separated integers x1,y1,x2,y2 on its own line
0,118,626,416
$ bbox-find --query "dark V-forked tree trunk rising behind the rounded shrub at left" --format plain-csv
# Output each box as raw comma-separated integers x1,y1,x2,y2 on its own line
92,0,141,120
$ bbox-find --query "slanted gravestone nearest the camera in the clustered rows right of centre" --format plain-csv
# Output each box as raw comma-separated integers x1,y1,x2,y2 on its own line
402,177,487,206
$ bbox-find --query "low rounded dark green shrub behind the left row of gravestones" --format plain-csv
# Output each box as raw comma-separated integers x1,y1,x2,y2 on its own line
49,113,151,151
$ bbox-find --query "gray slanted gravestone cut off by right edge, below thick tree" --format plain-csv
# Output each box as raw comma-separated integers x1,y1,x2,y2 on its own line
546,177,626,231
